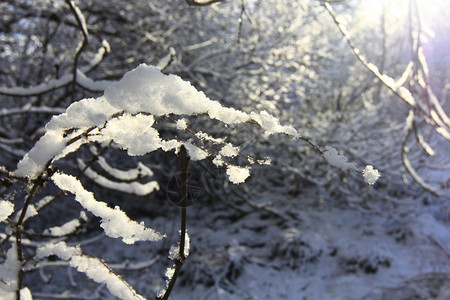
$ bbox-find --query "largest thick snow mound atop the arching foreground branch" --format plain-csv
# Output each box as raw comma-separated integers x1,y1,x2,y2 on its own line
15,64,297,181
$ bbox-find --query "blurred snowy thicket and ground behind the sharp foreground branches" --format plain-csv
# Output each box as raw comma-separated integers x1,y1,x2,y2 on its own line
0,0,450,300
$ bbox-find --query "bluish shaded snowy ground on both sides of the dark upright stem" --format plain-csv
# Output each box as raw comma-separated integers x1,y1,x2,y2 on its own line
26,183,450,300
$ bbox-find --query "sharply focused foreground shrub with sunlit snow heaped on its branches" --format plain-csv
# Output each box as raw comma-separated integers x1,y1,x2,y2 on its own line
0,64,378,299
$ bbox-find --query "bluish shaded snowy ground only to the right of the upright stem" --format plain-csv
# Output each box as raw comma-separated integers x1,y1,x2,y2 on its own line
169,191,450,300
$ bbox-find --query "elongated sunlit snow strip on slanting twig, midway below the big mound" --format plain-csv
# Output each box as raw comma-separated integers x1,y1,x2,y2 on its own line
52,173,164,244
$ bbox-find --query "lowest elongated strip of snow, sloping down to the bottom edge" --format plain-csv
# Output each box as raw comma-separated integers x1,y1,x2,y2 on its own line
36,242,145,300
